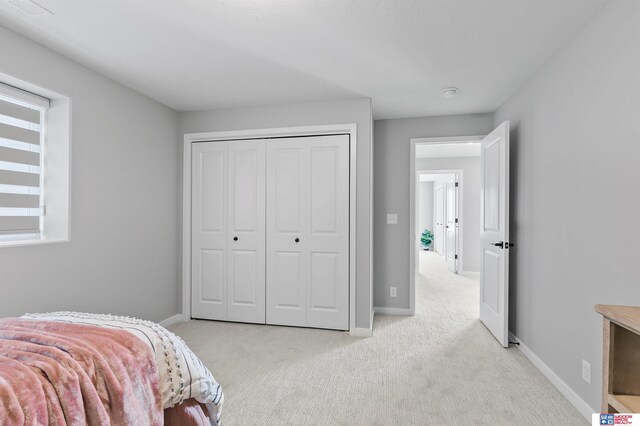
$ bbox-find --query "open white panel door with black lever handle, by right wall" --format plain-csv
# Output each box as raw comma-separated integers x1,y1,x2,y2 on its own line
480,121,510,348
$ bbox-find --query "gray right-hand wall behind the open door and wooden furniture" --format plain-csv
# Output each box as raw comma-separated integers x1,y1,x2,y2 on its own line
495,0,640,411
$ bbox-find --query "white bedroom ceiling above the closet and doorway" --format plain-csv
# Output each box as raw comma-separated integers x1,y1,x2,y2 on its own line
0,0,607,119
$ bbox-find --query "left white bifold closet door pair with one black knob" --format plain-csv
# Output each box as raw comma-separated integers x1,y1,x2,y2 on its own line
191,140,265,324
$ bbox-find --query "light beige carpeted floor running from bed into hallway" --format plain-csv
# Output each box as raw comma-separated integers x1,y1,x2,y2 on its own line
172,252,588,426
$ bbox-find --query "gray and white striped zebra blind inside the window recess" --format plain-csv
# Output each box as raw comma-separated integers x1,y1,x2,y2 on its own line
0,85,48,239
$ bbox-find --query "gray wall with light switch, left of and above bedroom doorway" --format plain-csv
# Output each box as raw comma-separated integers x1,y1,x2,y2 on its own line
373,114,493,309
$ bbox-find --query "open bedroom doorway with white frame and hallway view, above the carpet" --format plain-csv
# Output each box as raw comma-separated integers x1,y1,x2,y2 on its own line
409,136,482,316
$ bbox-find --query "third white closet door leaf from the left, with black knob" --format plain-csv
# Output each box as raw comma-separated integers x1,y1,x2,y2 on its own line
267,139,308,326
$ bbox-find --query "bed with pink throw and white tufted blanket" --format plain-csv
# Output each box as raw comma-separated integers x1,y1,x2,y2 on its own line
0,312,224,426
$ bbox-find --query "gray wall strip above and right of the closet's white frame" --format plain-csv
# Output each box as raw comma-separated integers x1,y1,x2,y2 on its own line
179,98,373,328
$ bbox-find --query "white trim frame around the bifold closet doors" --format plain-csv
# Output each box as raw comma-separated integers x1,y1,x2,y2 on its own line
181,123,358,335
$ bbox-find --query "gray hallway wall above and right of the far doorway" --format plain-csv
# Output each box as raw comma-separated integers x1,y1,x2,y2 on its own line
416,157,480,272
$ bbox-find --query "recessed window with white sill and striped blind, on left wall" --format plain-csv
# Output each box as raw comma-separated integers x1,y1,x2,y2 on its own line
0,78,71,247
